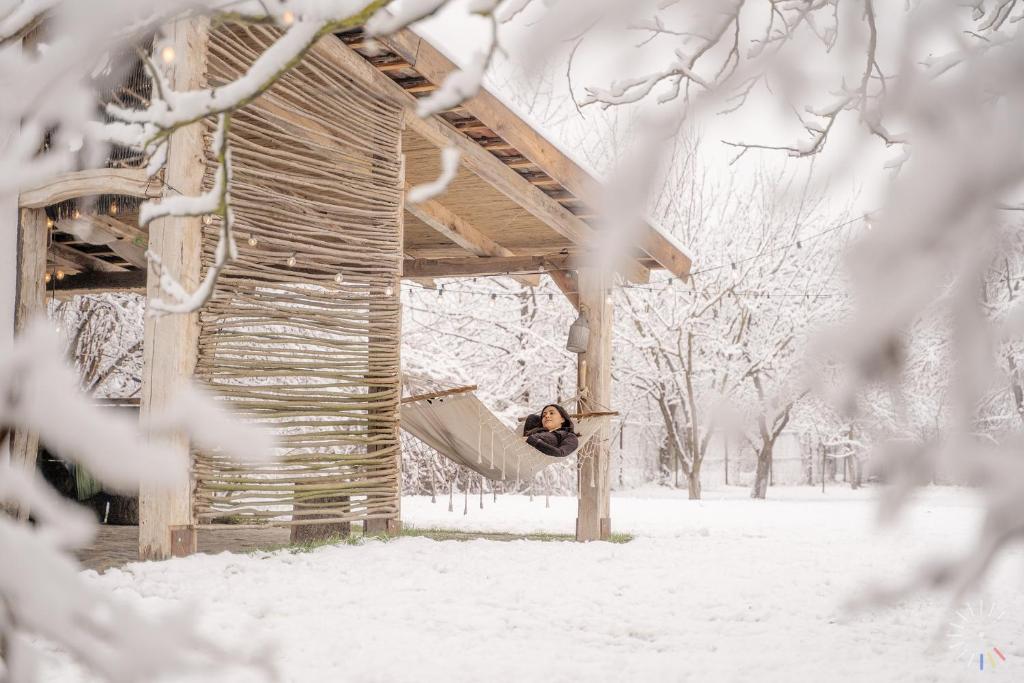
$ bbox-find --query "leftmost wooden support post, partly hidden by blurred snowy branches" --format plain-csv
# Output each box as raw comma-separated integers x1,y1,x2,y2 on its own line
10,209,49,519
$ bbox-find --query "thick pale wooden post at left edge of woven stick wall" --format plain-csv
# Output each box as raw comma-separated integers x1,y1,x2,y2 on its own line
138,18,209,560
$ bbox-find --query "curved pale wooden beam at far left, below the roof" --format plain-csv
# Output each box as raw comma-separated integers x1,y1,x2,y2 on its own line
18,168,163,209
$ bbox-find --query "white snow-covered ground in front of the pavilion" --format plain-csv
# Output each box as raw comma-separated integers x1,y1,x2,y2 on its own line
42,487,1024,683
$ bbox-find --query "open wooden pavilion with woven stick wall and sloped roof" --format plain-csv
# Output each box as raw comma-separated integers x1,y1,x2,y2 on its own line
13,20,690,558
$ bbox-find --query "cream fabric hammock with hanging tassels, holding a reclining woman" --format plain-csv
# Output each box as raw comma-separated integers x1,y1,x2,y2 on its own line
400,392,608,481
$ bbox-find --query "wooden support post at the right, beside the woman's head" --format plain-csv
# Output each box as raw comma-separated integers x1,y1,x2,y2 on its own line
577,268,612,541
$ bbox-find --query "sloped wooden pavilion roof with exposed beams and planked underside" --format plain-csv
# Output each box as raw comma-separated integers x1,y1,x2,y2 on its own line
20,23,690,303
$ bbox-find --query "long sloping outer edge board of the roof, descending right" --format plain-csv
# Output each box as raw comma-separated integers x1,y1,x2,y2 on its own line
380,29,691,279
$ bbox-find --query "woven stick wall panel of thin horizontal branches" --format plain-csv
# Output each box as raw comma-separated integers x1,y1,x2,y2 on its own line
195,26,402,524
